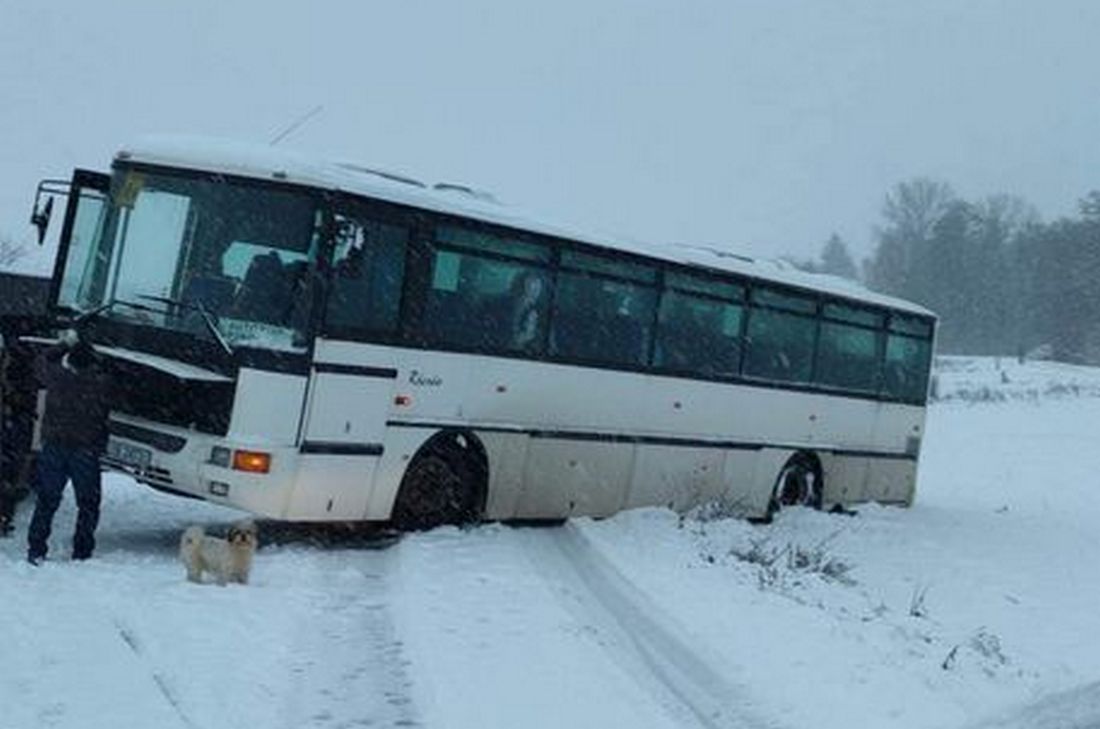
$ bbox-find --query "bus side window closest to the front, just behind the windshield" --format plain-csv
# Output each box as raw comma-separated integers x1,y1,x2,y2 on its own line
326,212,409,334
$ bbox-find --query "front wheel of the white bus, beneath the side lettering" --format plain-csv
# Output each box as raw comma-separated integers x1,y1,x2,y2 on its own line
393,432,486,531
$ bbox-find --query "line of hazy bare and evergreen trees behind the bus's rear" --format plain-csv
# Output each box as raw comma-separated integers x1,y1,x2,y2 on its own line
795,178,1100,364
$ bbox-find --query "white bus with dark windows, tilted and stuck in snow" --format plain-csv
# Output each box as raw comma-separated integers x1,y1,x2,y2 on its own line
36,137,935,528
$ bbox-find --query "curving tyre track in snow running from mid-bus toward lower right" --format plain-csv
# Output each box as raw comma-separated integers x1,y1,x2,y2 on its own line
526,523,782,729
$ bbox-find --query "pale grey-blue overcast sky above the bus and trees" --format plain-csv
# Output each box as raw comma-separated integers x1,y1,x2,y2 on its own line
0,0,1100,274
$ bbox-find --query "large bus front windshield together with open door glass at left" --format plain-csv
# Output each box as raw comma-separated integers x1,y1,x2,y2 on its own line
58,168,320,351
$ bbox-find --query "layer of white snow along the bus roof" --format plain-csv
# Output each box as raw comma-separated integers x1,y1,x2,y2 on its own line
117,134,934,317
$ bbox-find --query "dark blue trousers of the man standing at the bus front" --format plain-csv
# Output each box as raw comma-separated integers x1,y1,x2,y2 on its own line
28,443,102,560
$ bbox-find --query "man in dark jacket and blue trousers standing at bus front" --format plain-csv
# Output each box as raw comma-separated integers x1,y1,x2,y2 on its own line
26,331,110,564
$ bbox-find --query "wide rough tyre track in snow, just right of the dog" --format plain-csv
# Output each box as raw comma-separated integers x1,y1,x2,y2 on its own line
283,549,420,729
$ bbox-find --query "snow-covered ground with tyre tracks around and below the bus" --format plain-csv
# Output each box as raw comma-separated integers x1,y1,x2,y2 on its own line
0,360,1100,729
